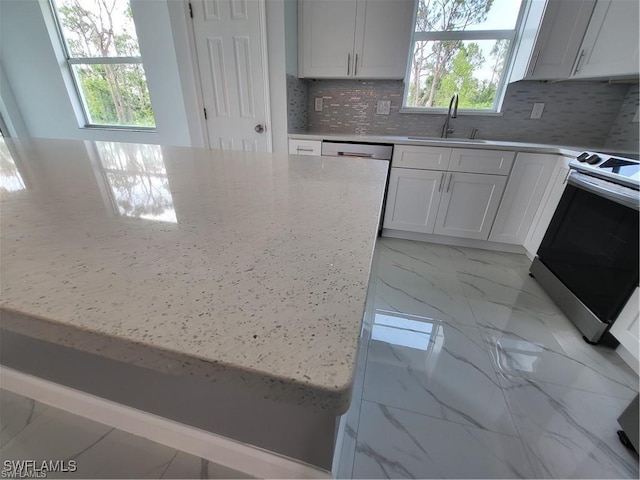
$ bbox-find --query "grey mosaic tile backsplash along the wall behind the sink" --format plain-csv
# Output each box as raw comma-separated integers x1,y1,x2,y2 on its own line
289,79,638,151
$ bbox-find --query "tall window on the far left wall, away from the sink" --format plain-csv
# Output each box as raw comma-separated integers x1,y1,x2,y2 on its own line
51,0,155,128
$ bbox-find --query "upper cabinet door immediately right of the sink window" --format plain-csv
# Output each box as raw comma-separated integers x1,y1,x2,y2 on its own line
526,0,596,80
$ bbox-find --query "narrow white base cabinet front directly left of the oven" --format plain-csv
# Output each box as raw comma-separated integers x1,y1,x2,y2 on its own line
524,156,572,257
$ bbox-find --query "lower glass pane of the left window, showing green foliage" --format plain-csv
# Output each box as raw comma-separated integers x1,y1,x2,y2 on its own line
73,63,155,127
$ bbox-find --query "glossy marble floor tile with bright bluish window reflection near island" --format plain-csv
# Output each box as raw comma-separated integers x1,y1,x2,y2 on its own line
363,310,516,435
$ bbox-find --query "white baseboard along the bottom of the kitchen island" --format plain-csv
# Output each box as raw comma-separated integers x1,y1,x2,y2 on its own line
0,366,332,478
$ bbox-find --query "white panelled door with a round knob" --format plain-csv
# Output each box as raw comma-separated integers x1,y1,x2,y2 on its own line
191,0,271,152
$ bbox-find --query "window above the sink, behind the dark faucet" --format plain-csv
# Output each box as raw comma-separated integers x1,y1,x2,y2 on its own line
404,0,522,111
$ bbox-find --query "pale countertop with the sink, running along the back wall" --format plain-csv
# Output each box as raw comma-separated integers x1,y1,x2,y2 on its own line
289,132,596,158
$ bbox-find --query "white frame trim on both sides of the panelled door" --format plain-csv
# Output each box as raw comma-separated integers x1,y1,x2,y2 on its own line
183,0,273,153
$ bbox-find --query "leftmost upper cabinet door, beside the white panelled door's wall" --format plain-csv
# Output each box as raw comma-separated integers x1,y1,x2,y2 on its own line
298,0,356,78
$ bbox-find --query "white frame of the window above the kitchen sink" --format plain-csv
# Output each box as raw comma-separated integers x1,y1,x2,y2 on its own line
400,0,529,116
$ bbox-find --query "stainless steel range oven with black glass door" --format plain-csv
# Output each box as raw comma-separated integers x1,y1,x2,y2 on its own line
531,152,640,343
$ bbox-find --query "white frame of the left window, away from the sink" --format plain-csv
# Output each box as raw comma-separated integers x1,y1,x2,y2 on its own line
47,0,158,132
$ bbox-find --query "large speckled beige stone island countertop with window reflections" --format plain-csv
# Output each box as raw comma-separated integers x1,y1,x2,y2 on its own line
0,139,389,414
